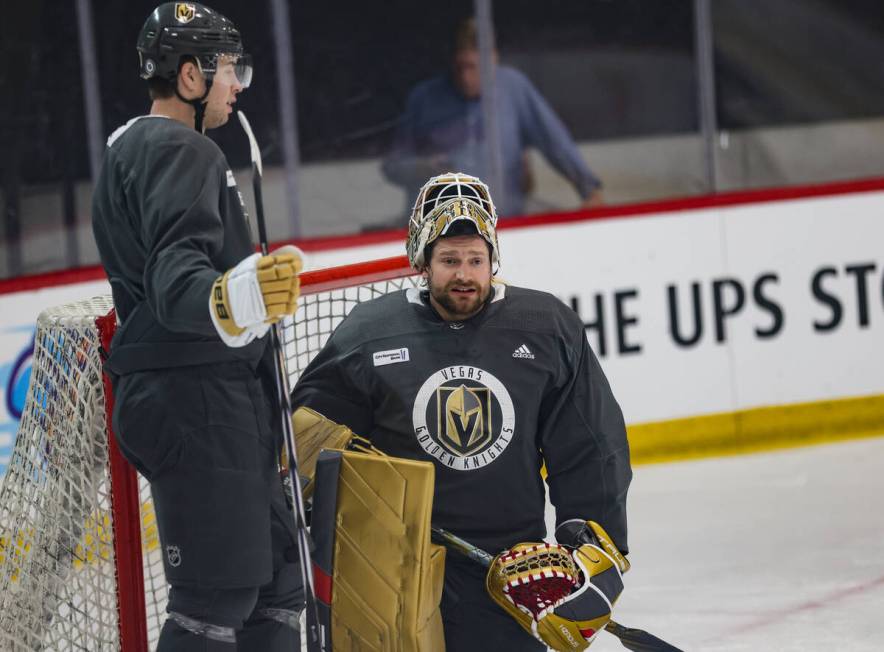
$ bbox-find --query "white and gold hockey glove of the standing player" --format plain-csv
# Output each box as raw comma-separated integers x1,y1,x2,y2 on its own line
209,245,304,347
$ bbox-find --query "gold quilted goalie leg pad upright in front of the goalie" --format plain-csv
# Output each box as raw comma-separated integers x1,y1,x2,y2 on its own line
311,450,445,652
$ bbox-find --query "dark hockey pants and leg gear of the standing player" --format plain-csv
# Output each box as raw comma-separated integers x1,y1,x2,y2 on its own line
114,362,303,652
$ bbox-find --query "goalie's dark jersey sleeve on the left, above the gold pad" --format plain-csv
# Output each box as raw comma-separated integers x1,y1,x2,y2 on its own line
291,332,374,437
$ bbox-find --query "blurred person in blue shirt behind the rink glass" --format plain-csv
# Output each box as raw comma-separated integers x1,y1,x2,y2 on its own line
382,18,602,216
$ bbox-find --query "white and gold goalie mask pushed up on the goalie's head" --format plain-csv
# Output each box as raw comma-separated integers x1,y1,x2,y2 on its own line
405,172,500,269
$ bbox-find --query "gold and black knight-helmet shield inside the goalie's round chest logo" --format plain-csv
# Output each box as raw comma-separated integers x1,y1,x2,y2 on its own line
436,385,492,456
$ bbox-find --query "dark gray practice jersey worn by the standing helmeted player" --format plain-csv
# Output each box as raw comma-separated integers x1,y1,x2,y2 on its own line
92,116,265,373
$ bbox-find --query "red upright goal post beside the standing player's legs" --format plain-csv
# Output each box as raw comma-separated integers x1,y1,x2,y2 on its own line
95,309,148,652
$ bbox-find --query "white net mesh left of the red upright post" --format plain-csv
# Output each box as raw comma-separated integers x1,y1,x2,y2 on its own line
0,299,117,650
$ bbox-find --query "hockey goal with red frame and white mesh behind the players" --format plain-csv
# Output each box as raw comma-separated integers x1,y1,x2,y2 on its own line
0,256,419,652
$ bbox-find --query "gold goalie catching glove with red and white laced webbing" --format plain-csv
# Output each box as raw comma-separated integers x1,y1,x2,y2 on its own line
485,521,629,650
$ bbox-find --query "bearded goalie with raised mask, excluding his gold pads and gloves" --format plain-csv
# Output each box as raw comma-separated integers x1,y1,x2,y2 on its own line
292,173,632,652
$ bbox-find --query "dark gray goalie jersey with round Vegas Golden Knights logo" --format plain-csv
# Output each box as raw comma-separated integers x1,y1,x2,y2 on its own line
293,284,632,553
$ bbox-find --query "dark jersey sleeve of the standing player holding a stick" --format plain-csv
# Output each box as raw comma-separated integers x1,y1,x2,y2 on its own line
136,137,225,336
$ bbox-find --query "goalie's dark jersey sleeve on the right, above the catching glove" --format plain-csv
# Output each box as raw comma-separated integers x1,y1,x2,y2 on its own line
540,314,632,554
